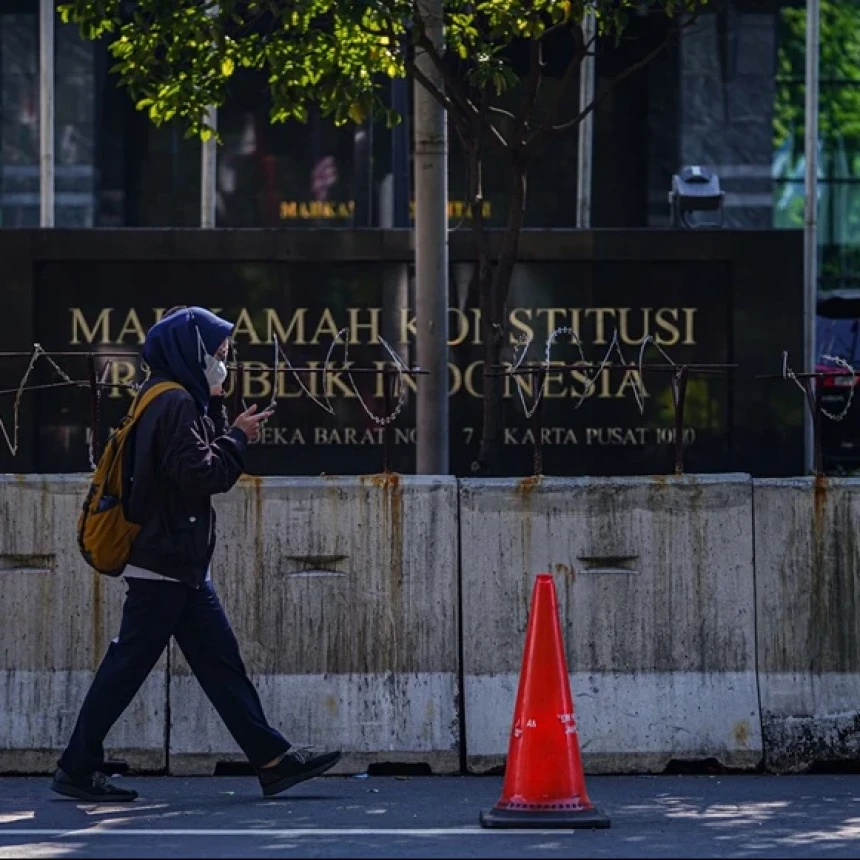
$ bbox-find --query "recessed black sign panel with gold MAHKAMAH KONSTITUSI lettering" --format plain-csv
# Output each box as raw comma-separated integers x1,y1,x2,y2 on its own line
36,261,732,475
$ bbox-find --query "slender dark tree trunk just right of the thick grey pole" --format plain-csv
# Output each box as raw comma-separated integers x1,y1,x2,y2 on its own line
472,159,526,475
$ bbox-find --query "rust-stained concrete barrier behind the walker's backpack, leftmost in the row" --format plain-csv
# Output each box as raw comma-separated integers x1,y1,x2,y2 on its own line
0,475,167,773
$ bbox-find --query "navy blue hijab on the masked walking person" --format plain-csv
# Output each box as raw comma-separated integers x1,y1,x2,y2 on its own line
143,307,234,413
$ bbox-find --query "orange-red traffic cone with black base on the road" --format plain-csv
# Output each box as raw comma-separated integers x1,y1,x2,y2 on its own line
481,573,609,828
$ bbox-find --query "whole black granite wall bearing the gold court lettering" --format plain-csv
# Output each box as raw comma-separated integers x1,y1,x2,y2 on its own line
0,225,803,475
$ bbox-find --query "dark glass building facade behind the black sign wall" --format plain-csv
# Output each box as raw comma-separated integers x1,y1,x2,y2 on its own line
0,0,860,249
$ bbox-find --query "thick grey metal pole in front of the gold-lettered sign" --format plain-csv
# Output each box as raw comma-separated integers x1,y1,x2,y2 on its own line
415,0,449,475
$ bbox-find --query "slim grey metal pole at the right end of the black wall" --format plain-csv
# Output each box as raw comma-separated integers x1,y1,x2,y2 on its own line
803,0,821,473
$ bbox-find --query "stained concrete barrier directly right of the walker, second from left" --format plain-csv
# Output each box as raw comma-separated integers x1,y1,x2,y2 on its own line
170,475,460,774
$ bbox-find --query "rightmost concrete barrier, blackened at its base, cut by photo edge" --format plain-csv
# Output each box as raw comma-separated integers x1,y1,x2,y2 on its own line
754,478,860,772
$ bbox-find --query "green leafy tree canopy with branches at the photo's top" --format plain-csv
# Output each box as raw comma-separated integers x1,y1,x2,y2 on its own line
60,0,699,148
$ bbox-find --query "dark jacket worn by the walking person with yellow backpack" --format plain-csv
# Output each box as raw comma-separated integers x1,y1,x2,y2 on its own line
125,386,248,588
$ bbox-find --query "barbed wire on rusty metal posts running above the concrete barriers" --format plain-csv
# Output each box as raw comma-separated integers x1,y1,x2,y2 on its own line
0,326,857,475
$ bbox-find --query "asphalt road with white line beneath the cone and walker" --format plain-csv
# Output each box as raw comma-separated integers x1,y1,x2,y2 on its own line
0,776,860,858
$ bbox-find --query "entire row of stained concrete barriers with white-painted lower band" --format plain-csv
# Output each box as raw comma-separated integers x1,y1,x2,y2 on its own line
10,475,860,774
